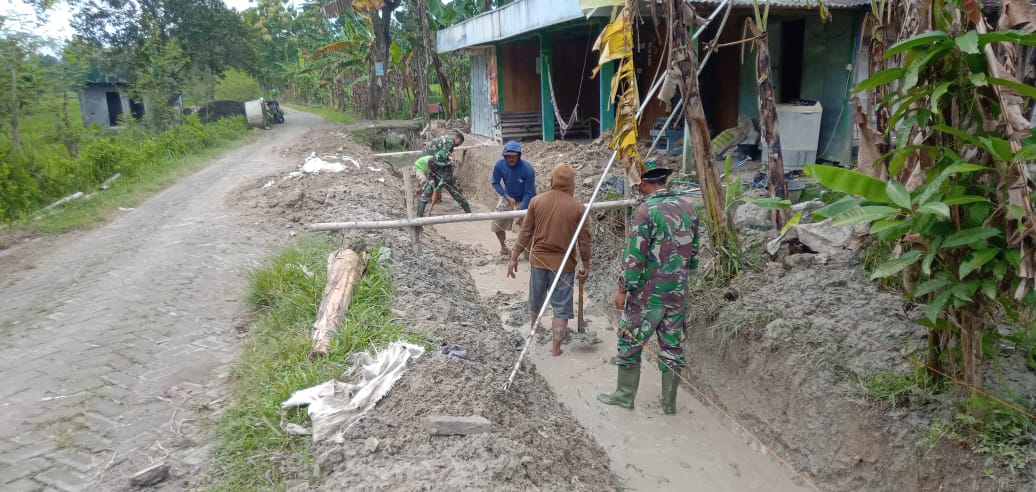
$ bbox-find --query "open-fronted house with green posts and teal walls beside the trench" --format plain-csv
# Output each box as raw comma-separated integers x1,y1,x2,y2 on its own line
436,0,869,163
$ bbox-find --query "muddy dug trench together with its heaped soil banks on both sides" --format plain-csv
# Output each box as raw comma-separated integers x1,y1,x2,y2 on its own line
228,125,1027,491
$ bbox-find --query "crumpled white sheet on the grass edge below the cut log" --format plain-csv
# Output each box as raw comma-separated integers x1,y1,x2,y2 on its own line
281,342,425,442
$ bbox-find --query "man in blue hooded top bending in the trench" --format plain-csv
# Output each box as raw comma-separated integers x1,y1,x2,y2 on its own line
490,140,536,256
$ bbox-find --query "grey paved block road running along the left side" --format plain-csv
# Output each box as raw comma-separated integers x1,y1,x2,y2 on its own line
0,112,324,491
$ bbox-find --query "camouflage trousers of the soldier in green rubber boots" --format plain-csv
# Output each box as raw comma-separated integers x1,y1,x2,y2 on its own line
615,298,687,373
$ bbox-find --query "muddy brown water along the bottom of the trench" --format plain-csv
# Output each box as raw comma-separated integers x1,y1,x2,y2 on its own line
435,222,807,492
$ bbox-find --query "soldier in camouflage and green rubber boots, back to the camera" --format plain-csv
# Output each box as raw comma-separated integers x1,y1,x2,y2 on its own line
597,162,698,415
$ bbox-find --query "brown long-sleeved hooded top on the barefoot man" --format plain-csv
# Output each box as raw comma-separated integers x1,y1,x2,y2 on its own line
516,164,591,272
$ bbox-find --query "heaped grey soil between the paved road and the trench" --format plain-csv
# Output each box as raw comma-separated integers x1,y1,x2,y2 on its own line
228,127,617,490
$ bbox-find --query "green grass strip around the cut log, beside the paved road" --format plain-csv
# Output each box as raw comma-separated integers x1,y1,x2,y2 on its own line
210,236,428,491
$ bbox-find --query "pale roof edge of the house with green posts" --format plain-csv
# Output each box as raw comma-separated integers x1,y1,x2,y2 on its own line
435,0,870,53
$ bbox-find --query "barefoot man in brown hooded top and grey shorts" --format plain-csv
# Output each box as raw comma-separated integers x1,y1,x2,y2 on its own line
508,164,591,357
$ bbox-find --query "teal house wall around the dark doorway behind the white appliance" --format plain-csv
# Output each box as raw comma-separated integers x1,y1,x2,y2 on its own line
733,10,859,163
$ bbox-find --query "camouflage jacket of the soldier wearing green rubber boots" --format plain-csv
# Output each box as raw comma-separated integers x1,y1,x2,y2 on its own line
620,190,698,307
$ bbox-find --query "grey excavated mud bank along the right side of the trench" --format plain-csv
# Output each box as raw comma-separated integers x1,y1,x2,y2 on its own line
685,253,995,490
